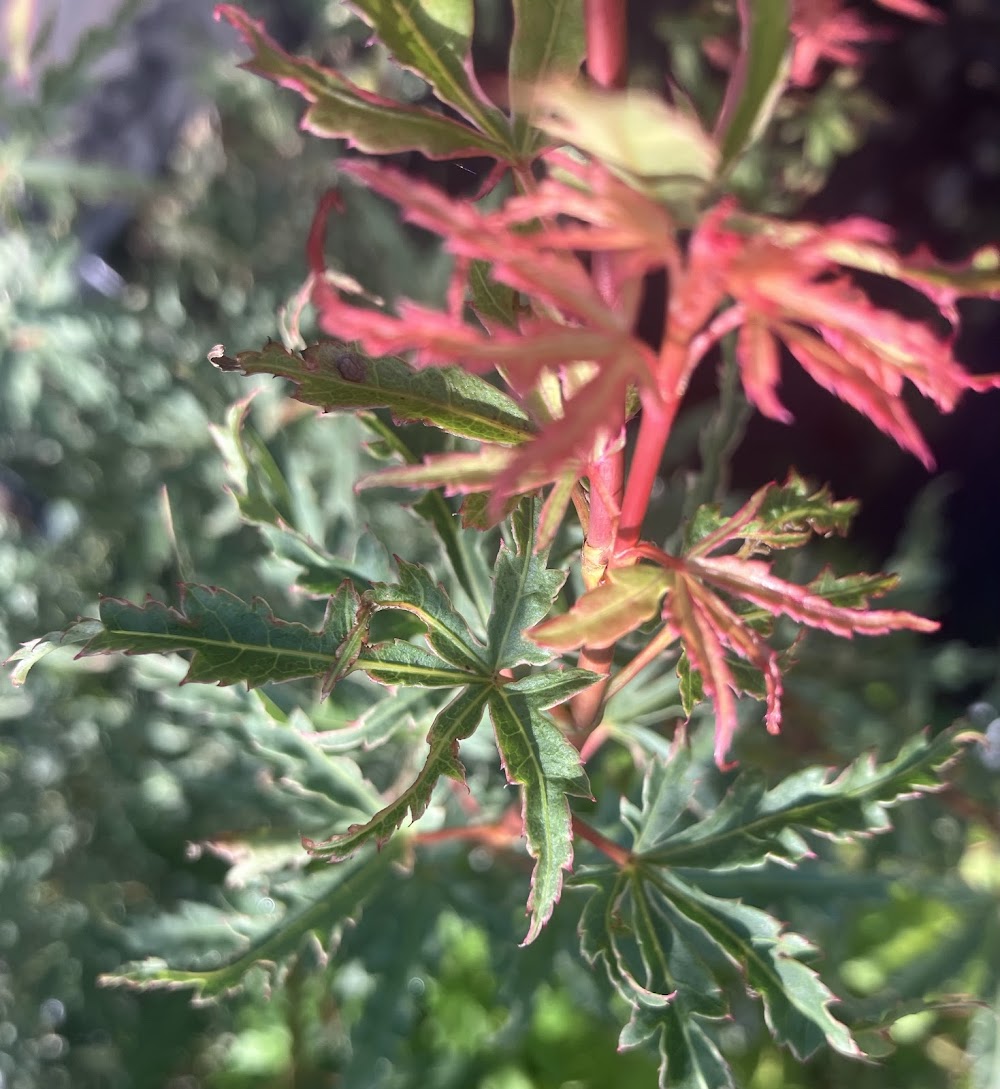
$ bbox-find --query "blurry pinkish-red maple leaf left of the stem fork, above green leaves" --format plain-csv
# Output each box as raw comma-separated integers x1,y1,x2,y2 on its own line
309,160,679,522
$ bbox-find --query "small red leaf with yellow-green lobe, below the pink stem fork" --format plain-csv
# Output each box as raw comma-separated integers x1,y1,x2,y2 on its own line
529,479,938,767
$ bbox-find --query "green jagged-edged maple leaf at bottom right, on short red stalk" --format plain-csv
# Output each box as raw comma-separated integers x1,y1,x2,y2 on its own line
576,731,965,1087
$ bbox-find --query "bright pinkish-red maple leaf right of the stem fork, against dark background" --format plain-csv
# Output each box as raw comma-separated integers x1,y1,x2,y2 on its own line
672,200,1000,467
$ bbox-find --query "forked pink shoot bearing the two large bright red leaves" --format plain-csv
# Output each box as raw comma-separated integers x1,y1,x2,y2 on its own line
309,156,1000,540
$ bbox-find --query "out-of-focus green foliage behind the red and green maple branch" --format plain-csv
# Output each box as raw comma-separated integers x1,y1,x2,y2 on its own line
0,2,1000,1089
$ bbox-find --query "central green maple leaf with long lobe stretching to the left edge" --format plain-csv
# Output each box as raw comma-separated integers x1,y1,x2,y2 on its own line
11,500,595,945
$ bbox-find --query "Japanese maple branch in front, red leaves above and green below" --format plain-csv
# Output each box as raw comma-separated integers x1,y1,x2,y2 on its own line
11,0,1000,1087
